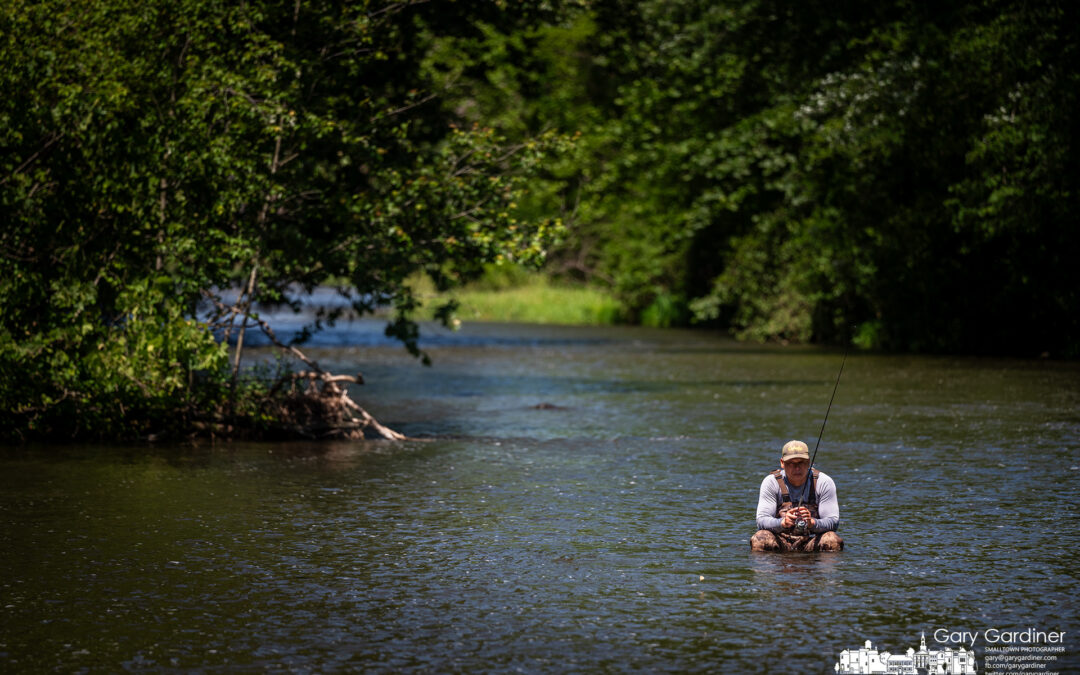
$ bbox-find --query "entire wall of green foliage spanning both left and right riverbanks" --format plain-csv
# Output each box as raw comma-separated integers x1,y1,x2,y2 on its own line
0,0,1080,437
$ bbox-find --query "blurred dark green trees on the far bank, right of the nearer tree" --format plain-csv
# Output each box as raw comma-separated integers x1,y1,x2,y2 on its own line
438,0,1080,356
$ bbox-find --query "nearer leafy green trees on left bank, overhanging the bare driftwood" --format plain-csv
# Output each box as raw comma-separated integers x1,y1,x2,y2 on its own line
0,0,570,437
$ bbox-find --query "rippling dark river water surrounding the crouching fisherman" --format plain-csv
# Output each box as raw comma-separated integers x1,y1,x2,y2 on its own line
0,322,1080,673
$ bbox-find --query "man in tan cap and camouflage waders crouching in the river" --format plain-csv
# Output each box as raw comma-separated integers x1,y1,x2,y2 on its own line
750,441,843,551
